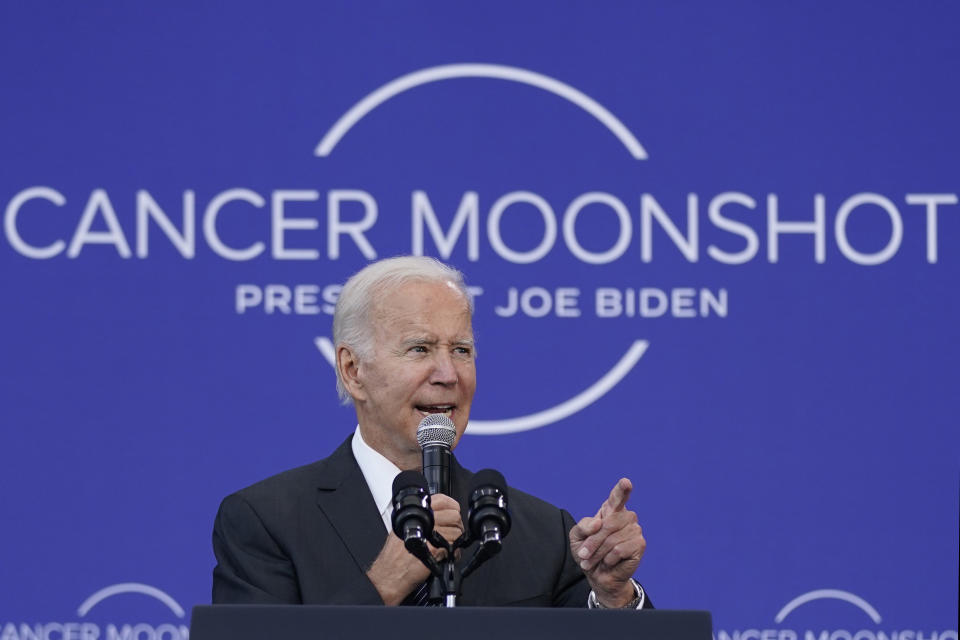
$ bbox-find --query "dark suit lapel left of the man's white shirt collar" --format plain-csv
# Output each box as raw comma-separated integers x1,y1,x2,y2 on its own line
317,435,387,573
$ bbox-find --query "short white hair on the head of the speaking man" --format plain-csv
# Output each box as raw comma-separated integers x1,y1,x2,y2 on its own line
333,256,473,404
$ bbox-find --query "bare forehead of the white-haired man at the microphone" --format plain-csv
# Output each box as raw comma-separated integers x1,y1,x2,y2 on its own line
371,281,473,340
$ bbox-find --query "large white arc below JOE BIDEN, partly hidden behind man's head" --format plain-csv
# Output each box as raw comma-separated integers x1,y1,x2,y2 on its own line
313,336,650,436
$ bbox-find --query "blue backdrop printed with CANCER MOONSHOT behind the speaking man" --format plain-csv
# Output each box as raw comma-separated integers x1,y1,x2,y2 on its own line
0,2,960,640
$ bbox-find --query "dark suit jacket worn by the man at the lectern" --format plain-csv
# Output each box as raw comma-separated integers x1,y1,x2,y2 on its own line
213,436,648,607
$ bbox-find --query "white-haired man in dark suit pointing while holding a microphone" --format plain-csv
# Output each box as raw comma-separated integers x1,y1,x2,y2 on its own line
213,257,651,608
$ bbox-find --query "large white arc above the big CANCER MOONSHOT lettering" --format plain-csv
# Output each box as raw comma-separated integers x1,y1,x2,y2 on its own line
314,63,647,160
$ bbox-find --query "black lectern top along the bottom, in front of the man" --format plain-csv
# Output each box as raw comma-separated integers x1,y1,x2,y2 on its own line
190,605,713,640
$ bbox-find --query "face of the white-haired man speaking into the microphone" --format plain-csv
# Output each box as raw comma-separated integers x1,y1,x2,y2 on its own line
354,282,476,469
